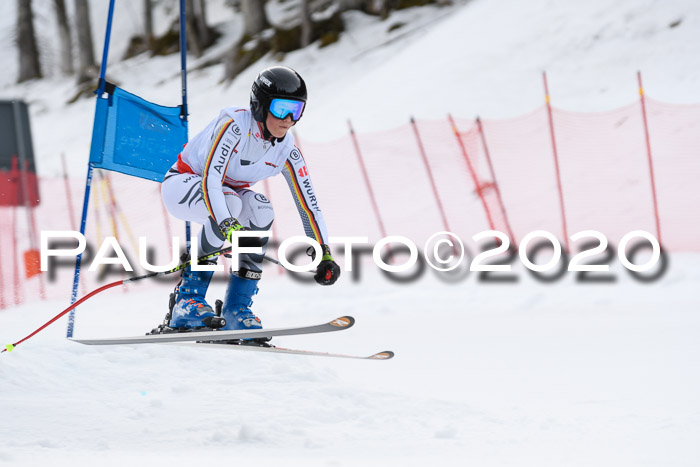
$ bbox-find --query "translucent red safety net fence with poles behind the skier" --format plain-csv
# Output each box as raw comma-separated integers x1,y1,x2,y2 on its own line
0,98,700,308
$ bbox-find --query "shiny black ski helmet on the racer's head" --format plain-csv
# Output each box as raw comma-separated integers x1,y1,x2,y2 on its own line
250,66,306,125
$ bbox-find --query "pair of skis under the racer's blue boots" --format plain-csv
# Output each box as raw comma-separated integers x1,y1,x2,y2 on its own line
72,316,394,360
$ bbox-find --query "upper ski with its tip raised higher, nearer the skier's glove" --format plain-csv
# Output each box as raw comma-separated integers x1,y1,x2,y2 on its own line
71,316,355,345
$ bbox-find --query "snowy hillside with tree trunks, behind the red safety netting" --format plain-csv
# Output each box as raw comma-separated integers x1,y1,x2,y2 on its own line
0,0,700,175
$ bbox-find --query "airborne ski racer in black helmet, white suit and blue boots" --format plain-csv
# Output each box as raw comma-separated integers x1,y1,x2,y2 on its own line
161,66,340,330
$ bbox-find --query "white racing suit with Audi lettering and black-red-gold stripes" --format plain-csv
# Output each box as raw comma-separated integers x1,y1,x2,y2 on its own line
161,107,328,271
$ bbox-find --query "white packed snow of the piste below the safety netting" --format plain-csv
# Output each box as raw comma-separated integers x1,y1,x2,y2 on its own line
0,262,700,467
